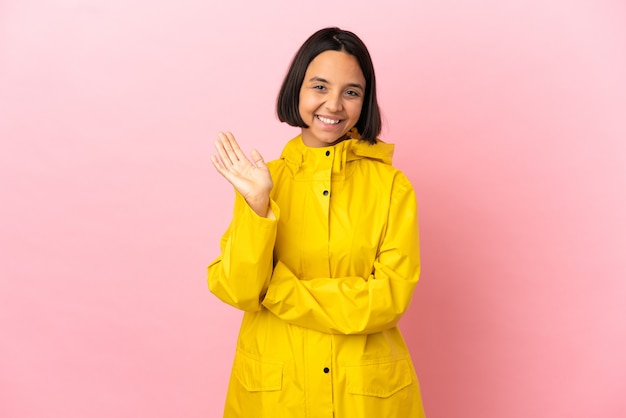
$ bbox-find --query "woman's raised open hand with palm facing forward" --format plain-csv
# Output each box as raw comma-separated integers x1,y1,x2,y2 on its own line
211,132,273,216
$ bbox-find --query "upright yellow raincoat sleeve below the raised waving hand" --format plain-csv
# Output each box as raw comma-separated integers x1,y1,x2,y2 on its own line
208,193,279,311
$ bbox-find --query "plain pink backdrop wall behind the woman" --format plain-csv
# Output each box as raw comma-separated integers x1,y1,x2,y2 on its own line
0,0,626,418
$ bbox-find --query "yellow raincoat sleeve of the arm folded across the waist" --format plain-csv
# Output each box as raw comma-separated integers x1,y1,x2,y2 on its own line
263,175,420,334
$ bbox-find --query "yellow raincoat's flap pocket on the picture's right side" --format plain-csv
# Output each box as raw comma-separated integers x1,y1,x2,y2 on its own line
346,359,413,398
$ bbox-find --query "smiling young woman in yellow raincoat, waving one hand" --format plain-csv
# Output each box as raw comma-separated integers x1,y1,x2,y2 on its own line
208,28,424,418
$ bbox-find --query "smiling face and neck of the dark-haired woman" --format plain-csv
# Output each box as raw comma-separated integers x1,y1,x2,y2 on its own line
299,51,365,147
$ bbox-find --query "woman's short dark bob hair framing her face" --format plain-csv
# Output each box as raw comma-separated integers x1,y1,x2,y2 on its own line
276,28,382,144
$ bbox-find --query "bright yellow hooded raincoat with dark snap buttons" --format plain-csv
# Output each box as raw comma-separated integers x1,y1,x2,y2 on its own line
208,134,424,418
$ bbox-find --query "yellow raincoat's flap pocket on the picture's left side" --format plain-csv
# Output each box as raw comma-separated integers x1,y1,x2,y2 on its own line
233,350,283,392
